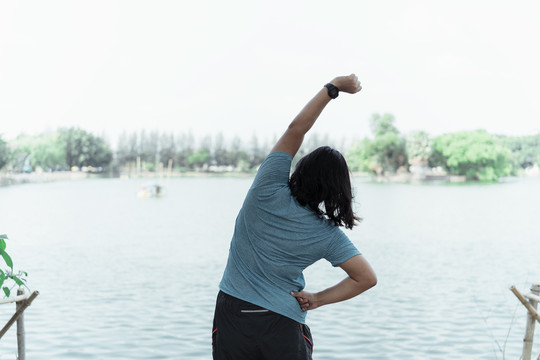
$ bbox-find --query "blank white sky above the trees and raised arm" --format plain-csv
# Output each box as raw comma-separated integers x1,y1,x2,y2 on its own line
0,0,540,145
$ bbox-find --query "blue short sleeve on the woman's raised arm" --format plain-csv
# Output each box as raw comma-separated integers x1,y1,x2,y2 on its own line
251,152,292,188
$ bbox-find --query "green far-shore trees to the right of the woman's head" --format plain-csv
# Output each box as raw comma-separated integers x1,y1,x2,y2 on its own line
347,114,540,181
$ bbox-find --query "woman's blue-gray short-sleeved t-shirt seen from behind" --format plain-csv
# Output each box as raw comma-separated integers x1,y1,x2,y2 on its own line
219,152,360,324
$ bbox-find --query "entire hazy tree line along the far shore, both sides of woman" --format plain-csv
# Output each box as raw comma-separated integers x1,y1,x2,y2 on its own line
0,114,540,181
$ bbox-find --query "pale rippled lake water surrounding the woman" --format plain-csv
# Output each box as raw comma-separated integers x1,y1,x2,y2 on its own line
0,178,540,360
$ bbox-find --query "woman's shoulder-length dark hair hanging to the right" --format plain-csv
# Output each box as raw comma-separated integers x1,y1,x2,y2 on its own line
289,146,361,229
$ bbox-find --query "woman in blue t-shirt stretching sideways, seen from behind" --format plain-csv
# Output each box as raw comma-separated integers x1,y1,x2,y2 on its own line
212,74,377,360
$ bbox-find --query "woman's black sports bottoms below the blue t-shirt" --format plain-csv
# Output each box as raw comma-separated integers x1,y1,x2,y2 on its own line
212,291,313,360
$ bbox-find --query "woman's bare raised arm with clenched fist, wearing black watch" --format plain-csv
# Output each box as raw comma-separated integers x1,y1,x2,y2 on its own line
271,74,362,157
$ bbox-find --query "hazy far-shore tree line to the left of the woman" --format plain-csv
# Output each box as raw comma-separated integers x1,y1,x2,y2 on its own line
0,127,276,172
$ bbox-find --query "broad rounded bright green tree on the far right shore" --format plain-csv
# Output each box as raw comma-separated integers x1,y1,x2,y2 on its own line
430,130,512,181
